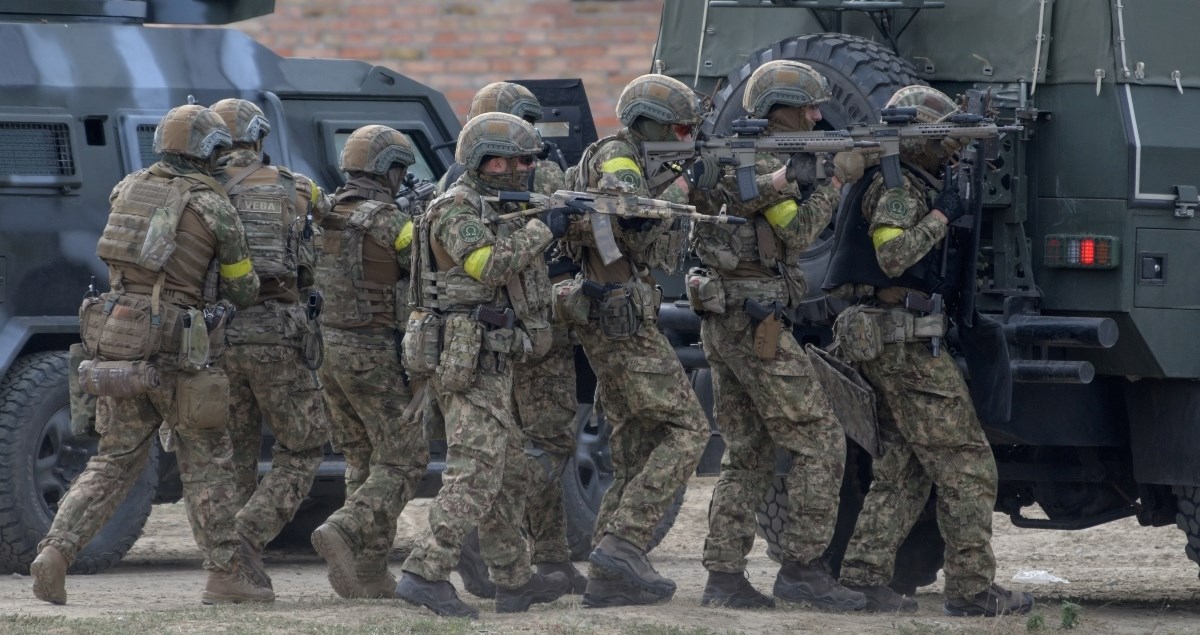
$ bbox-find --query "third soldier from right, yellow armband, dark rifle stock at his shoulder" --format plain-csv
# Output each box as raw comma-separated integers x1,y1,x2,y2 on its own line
554,74,708,607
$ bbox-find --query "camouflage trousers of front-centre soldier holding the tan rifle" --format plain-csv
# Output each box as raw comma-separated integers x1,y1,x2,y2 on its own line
403,352,533,588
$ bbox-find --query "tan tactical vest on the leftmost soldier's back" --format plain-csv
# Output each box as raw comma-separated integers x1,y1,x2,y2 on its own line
96,166,224,304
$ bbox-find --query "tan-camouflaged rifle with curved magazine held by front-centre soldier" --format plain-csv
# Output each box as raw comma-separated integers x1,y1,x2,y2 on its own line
485,190,746,264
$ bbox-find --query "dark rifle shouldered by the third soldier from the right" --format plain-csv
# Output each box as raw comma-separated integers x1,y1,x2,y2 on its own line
642,118,880,200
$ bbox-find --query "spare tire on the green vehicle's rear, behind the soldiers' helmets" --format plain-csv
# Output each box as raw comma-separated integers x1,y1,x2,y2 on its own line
702,34,924,322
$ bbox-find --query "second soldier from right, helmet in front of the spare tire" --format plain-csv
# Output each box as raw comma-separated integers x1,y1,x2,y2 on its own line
688,60,866,610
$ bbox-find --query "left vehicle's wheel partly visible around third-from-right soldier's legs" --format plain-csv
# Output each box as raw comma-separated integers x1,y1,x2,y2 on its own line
563,403,686,562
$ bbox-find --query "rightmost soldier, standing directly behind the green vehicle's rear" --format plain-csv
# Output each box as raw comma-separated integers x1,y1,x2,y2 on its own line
826,86,1033,616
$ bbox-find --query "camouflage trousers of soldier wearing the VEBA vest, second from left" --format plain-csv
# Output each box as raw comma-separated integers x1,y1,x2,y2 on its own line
221,311,329,549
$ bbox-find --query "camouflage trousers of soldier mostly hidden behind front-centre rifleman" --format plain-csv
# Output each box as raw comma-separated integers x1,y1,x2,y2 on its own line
512,327,578,563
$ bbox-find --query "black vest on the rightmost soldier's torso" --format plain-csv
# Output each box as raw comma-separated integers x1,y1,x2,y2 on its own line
821,162,942,293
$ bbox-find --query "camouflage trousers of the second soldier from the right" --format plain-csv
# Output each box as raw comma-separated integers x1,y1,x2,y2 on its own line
700,308,846,573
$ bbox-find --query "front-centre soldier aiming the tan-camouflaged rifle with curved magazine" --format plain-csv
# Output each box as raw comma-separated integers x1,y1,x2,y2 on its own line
396,113,570,617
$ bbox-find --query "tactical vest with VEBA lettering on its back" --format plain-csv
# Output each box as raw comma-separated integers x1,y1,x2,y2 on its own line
224,163,302,289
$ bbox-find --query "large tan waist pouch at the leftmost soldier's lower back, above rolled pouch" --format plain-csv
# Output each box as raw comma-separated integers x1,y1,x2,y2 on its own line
79,293,168,361
